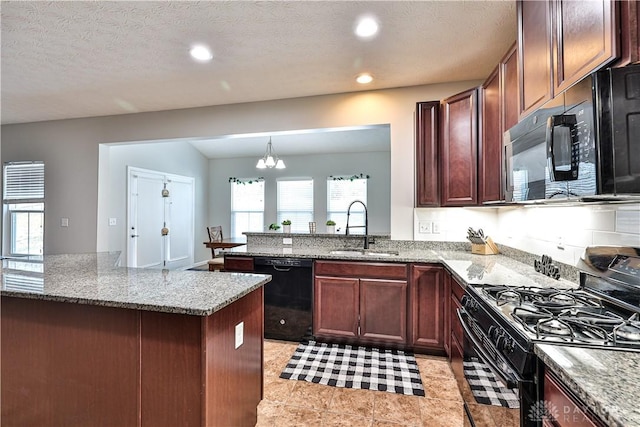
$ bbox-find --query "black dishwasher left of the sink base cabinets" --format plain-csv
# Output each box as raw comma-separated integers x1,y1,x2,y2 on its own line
254,257,313,342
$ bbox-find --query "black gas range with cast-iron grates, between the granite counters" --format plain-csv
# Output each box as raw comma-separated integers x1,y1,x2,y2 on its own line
459,246,640,426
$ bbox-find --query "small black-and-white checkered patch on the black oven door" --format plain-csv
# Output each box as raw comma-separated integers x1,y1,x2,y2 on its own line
463,360,520,409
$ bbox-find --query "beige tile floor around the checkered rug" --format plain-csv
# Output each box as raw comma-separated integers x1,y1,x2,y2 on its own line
256,340,464,427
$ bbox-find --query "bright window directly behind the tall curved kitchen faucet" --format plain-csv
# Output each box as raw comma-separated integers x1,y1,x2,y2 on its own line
327,178,367,234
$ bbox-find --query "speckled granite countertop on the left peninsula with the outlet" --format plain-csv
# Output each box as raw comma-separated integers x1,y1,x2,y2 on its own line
0,252,271,316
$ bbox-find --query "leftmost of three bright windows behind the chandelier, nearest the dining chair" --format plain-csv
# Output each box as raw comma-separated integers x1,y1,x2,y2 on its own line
231,180,264,237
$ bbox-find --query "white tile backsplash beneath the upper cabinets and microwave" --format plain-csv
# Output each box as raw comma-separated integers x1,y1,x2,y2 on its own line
413,203,640,265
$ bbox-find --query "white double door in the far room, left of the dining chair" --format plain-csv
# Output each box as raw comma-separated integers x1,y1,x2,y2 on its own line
127,167,195,269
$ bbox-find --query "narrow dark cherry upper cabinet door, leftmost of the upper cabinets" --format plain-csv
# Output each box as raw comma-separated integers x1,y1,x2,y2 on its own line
416,101,440,207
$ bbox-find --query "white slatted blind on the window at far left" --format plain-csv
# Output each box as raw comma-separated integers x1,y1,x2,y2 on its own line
3,162,44,202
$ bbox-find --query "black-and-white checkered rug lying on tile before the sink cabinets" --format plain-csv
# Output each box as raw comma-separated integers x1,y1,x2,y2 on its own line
280,341,424,396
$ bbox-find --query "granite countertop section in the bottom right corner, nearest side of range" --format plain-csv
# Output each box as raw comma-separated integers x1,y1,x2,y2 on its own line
534,344,640,427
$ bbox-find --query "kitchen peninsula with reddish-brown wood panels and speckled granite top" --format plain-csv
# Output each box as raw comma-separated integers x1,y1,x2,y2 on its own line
1,253,270,426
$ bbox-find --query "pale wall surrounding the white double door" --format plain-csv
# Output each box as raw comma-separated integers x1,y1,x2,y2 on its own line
97,142,211,261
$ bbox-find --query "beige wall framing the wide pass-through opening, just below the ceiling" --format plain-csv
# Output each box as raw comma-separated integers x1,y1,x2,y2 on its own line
1,81,480,254
